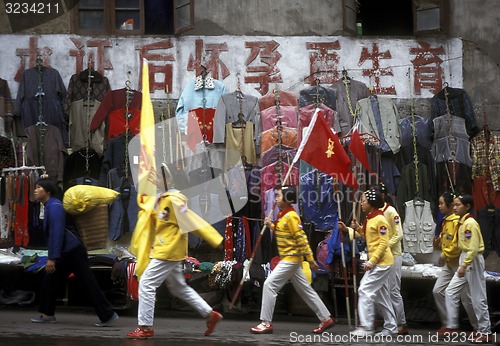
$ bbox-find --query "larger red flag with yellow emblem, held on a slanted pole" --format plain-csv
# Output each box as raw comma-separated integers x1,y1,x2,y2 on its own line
293,110,358,188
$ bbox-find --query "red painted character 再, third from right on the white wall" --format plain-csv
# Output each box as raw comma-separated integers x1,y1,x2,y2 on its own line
305,40,340,85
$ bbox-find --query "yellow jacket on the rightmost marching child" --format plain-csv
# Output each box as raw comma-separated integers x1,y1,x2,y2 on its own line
458,214,484,267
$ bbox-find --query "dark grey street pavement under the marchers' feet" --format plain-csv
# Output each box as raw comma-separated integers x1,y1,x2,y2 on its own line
0,306,498,346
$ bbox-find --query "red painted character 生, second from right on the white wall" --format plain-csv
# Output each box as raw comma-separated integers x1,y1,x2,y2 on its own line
358,43,396,95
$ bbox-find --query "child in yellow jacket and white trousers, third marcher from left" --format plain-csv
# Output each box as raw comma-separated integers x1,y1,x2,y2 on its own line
339,189,398,338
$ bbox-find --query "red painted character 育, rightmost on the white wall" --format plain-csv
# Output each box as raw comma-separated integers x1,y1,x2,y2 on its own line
410,41,444,95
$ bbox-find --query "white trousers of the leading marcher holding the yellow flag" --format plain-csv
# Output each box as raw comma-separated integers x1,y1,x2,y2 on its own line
138,258,212,326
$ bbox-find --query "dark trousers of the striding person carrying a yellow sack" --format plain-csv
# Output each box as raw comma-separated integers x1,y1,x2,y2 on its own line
38,245,114,321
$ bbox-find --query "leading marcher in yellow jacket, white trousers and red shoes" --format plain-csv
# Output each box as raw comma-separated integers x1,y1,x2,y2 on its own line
127,190,224,339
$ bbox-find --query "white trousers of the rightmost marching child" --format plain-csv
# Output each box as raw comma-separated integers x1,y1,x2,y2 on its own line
446,252,491,334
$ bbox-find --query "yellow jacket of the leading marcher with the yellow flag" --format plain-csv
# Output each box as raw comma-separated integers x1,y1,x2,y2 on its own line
152,190,224,261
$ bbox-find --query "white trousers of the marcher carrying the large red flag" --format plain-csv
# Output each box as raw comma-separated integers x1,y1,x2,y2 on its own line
260,260,330,322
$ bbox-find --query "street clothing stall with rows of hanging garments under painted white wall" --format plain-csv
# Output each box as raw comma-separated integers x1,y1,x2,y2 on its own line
0,0,500,324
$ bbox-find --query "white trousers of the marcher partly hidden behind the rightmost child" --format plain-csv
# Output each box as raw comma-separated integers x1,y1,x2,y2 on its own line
432,264,478,330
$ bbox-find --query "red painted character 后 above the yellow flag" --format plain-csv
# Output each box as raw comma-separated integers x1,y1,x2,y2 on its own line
136,40,175,93
